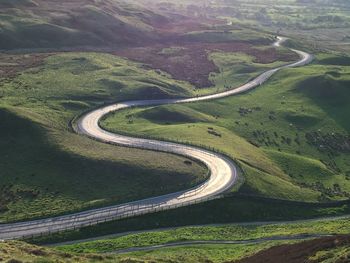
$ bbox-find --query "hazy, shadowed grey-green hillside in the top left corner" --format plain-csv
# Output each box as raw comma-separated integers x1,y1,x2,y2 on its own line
0,0,162,49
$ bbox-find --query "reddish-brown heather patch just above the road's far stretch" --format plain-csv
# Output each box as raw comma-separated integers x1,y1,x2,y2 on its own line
115,42,295,88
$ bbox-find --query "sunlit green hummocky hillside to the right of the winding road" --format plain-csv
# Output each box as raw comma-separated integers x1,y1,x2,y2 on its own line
101,54,350,201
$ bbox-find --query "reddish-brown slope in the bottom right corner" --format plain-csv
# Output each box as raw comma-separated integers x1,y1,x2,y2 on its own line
235,236,350,263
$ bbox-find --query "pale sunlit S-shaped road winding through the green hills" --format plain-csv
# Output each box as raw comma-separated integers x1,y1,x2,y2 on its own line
0,37,312,240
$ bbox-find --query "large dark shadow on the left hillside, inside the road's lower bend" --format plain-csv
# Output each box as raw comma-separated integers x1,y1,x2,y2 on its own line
0,109,201,220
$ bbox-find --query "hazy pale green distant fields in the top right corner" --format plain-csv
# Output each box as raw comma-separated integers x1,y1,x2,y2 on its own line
198,0,350,53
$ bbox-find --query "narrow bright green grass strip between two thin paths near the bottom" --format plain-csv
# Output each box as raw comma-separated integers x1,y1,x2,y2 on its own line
58,218,350,253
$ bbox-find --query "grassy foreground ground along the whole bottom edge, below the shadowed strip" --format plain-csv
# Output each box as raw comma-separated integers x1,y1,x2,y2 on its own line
0,220,349,263
